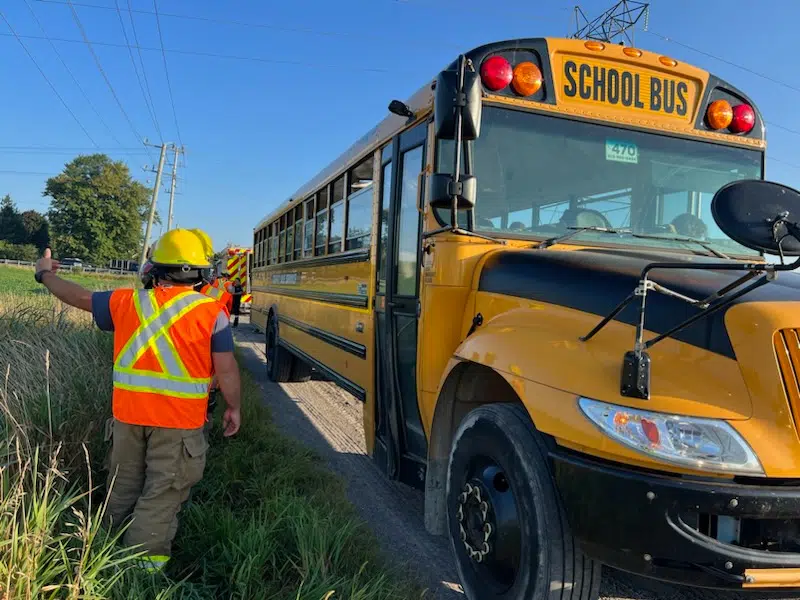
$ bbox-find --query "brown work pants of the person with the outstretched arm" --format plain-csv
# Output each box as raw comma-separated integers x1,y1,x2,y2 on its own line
106,418,208,562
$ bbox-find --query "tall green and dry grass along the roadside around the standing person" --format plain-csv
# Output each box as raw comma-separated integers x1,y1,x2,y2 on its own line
0,297,424,600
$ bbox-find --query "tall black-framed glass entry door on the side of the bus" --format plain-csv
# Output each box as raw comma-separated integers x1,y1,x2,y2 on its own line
374,124,427,487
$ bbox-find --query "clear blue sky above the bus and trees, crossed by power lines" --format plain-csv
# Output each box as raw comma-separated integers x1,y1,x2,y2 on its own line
0,0,800,248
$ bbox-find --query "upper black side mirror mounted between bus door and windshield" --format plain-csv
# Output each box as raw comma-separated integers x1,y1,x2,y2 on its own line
433,69,483,141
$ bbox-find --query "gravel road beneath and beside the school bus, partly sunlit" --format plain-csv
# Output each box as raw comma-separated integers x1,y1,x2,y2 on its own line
236,318,798,600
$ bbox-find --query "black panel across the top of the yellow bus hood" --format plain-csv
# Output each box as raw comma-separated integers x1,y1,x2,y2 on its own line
478,249,800,359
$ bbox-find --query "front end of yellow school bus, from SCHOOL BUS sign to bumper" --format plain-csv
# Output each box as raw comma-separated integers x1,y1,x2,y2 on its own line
417,39,800,598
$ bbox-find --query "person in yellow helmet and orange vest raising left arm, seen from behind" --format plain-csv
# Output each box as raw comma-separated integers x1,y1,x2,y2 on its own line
35,229,241,571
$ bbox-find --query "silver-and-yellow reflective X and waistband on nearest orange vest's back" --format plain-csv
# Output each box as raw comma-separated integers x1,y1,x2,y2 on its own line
114,290,214,399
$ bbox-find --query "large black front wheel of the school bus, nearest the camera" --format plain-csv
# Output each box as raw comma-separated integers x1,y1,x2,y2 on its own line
447,404,601,600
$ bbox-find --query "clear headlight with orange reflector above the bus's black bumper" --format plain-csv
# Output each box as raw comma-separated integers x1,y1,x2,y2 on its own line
578,398,765,476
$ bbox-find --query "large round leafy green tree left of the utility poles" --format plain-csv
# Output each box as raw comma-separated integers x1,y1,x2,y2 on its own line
43,154,155,264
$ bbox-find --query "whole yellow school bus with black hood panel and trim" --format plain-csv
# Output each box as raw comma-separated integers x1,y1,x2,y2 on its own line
252,38,800,600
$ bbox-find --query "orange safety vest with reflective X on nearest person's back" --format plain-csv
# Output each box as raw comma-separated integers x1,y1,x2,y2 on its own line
110,286,220,429
